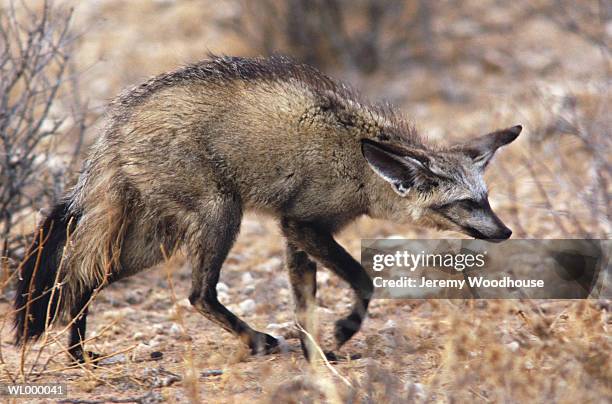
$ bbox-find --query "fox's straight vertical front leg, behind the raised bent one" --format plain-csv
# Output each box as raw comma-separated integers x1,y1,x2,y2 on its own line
285,241,317,359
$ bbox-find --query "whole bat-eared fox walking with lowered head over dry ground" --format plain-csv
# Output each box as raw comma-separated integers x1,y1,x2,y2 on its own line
15,56,521,361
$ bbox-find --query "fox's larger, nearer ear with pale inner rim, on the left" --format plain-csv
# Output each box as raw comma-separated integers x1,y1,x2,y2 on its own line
361,139,435,196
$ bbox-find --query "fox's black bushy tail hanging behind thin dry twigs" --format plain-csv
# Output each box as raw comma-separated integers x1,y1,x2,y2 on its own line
15,202,78,344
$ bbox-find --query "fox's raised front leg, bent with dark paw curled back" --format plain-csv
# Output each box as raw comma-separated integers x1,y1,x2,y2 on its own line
282,219,374,354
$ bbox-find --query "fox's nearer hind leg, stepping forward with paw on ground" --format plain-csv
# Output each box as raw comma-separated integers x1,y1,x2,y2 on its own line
189,198,278,354
